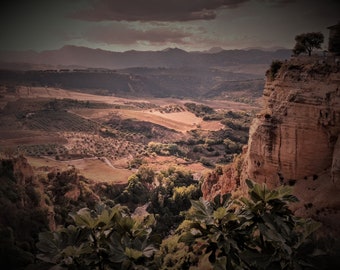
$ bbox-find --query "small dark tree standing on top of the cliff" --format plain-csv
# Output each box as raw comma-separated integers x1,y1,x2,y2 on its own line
293,32,324,56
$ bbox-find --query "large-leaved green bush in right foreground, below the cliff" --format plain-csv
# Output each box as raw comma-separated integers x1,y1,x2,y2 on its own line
159,181,321,270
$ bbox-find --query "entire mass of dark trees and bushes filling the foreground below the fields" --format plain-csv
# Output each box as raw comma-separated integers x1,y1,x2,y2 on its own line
0,154,333,270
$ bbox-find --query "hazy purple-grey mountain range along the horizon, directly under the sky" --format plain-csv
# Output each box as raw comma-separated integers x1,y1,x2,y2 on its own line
0,46,291,69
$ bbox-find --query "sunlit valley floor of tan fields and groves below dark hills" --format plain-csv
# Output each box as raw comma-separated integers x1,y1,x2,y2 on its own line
0,86,258,184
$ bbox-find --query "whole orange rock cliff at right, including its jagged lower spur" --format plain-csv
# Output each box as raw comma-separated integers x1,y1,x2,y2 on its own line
203,54,340,234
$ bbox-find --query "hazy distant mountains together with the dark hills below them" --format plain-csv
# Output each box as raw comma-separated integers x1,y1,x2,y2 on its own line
0,46,291,100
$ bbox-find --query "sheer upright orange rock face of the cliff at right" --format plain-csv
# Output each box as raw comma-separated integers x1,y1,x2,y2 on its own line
243,58,340,186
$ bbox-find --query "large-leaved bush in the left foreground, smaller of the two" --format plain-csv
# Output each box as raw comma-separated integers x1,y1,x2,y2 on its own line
37,205,155,270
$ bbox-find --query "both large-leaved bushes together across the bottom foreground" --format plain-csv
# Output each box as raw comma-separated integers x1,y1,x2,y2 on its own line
37,181,334,270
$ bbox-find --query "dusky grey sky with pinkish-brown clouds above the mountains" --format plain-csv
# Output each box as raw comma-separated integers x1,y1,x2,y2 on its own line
0,0,340,52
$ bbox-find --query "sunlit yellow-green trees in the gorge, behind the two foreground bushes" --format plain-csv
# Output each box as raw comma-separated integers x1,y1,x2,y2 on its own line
115,165,202,236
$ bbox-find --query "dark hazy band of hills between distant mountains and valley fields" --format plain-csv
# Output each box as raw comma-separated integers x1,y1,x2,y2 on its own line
0,68,264,98
